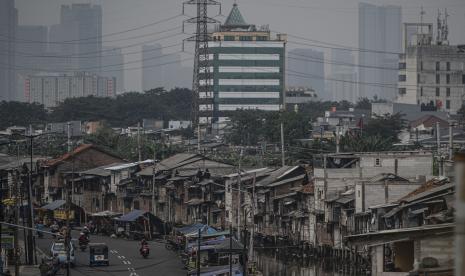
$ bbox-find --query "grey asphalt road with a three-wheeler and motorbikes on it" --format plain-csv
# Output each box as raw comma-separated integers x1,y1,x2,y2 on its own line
36,233,187,276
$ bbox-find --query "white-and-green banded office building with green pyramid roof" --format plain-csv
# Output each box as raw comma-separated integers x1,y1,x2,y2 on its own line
204,4,286,123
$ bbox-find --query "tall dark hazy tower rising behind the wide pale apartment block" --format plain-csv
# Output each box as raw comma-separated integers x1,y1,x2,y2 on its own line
59,4,102,72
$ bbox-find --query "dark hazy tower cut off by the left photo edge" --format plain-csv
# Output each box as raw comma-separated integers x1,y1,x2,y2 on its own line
0,0,18,101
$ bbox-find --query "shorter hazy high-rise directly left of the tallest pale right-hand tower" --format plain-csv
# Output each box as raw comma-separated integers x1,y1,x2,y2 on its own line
327,49,358,103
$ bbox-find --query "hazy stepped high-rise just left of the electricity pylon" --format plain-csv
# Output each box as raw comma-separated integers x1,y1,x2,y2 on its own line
142,44,192,91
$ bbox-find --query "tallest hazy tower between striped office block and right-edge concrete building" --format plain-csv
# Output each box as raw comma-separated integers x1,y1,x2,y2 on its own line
358,3,402,100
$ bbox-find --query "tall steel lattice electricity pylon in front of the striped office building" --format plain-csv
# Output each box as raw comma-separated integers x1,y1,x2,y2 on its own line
182,0,221,142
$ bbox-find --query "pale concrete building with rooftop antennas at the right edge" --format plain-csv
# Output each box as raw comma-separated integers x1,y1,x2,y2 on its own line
397,20,465,114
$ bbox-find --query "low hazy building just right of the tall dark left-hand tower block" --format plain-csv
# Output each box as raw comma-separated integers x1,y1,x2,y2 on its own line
100,47,124,93
